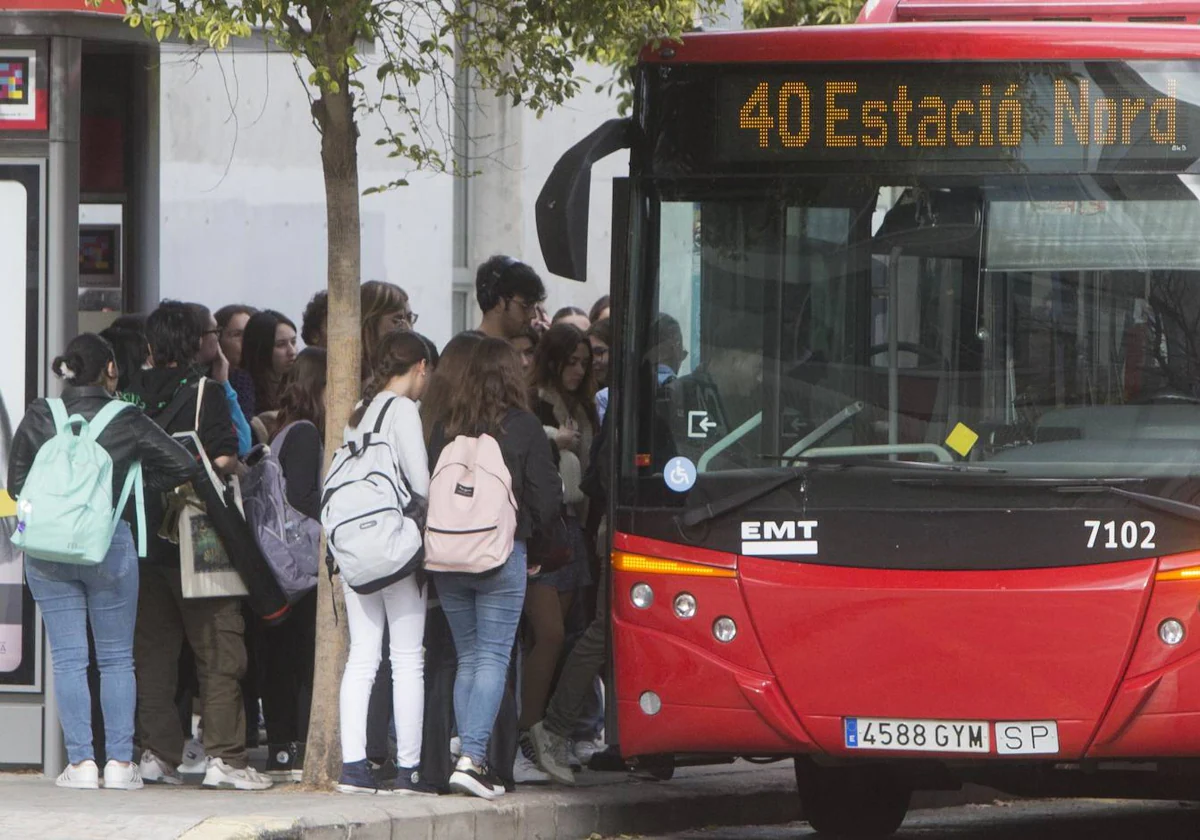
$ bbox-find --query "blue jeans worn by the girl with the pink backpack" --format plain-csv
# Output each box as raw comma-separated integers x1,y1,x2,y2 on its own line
436,542,527,764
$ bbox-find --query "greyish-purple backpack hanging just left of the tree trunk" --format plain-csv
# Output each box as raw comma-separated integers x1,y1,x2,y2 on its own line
241,420,320,604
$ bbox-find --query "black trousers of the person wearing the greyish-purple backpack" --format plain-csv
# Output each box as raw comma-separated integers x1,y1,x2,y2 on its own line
258,589,317,746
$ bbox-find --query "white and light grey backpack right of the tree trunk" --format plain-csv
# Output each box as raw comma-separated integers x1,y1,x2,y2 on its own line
320,397,421,594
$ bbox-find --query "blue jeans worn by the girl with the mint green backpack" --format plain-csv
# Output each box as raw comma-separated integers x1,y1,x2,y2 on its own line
25,522,138,764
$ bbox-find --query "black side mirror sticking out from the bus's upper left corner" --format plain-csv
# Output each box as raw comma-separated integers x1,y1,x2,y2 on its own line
535,118,634,283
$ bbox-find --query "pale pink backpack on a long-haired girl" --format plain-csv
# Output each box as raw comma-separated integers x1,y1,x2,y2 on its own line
425,434,517,575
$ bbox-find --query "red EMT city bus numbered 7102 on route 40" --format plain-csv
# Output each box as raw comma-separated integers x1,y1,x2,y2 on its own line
539,0,1200,836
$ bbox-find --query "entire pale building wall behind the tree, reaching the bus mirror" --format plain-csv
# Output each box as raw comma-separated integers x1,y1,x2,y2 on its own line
158,38,628,343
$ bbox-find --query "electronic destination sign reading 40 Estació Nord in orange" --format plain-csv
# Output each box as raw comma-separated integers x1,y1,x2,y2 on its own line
716,62,1200,162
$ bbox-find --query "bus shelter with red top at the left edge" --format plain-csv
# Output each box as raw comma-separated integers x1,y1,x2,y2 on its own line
0,0,158,774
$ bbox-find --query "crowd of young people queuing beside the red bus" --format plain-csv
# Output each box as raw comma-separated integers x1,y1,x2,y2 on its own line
8,257,612,799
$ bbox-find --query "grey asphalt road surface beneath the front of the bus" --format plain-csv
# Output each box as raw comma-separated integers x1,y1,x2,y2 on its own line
646,799,1200,840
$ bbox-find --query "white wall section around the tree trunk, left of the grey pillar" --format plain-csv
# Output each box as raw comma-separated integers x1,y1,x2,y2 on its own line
160,49,452,340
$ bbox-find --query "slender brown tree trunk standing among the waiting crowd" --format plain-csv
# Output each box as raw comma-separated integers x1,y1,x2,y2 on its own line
304,75,357,787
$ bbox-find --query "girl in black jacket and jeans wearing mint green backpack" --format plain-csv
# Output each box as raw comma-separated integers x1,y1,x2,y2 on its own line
8,332,198,790
